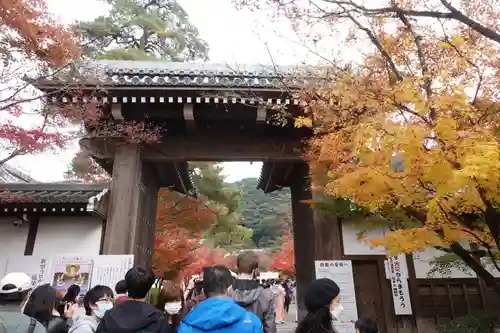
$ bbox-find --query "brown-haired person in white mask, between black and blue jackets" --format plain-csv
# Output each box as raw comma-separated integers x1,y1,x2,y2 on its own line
156,281,184,332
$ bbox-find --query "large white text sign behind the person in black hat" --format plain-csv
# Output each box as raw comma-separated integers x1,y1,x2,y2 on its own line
314,260,358,326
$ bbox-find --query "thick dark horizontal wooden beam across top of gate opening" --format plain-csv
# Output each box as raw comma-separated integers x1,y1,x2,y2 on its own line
80,134,303,162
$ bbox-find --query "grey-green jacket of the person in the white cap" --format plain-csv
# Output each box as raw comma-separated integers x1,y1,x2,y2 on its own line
0,304,47,333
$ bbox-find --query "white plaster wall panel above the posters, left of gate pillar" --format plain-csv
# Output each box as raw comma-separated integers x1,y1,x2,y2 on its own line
33,216,102,256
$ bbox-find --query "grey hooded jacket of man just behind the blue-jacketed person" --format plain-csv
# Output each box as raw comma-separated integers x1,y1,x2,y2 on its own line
232,280,276,333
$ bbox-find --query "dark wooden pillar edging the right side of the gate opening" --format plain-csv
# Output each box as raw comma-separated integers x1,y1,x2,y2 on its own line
291,163,314,320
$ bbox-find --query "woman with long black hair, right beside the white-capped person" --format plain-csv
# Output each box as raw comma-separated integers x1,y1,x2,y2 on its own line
24,284,71,333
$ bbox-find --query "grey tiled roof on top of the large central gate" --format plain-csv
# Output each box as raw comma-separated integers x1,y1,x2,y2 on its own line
35,60,325,89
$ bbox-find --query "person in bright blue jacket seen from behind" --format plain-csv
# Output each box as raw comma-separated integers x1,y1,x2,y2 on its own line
178,266,263,333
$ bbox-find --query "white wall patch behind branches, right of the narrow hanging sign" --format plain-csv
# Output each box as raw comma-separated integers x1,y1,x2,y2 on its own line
413,248,476,279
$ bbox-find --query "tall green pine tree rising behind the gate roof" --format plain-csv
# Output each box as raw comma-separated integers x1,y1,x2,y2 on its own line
76,0,208,61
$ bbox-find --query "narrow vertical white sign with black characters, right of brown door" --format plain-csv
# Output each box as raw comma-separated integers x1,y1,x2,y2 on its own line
389,256,412,316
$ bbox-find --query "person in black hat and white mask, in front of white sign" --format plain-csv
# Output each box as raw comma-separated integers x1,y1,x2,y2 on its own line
295,279,344,333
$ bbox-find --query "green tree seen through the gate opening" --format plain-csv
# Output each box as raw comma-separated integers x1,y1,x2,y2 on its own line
190,163,253,249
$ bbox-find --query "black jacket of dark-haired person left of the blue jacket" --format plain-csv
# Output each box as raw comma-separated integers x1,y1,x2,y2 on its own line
96,300,170,333
